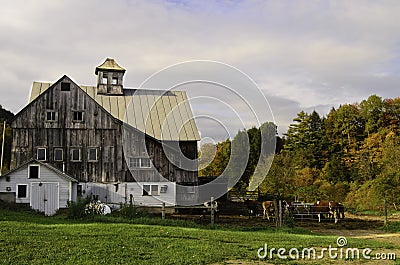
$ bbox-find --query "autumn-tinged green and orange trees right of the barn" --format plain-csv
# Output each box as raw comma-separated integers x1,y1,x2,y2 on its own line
199,95,400,210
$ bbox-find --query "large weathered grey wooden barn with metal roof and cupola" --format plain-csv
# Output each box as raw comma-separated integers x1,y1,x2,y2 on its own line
6,58,200,204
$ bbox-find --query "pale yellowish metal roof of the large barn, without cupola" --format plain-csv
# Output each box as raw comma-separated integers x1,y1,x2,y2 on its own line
29,82,200,141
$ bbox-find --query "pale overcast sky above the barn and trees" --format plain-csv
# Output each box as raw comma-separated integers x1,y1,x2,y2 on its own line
0,0,400,140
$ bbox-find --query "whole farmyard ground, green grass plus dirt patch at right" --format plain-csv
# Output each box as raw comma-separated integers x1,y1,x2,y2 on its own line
0,203,400,264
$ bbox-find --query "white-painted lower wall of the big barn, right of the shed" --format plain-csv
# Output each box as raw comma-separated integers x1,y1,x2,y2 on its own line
78,182,176,206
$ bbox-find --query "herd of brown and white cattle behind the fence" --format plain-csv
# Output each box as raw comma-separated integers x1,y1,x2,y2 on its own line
244,199,344,223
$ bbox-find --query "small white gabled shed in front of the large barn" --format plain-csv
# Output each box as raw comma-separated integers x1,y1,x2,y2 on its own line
0,160,78,215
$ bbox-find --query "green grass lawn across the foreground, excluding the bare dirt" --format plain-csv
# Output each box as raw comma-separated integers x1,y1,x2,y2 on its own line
0,209,399,264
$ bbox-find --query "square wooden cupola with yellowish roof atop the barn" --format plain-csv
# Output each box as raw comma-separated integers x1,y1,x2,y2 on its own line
95,58,126,95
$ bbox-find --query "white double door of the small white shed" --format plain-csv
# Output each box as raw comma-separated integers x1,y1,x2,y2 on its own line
31,182,59,215
